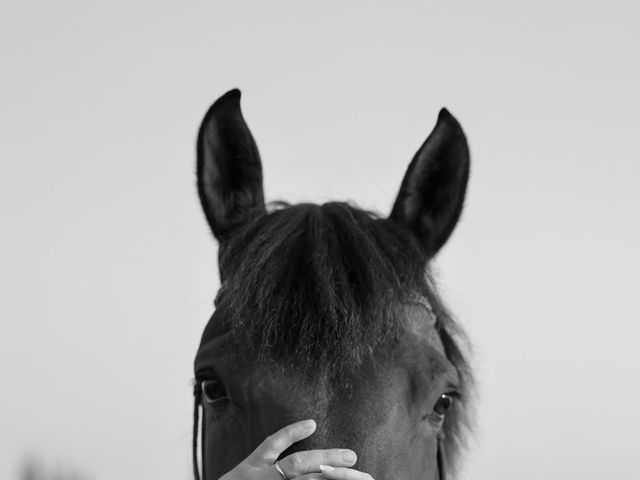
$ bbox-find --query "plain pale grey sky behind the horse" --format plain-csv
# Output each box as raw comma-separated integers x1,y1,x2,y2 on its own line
0,0,640,480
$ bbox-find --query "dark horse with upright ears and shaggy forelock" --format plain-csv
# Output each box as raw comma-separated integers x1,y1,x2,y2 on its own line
193,89,473,480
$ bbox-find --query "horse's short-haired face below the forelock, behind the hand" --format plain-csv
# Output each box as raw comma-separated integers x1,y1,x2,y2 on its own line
198,304,460,480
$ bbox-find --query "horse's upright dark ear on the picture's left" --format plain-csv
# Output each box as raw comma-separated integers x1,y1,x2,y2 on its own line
197,90,264,240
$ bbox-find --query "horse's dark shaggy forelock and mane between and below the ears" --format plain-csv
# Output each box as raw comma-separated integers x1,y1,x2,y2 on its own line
216,202,472,466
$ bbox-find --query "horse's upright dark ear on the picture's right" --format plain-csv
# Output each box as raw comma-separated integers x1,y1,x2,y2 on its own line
390,108,469,258
